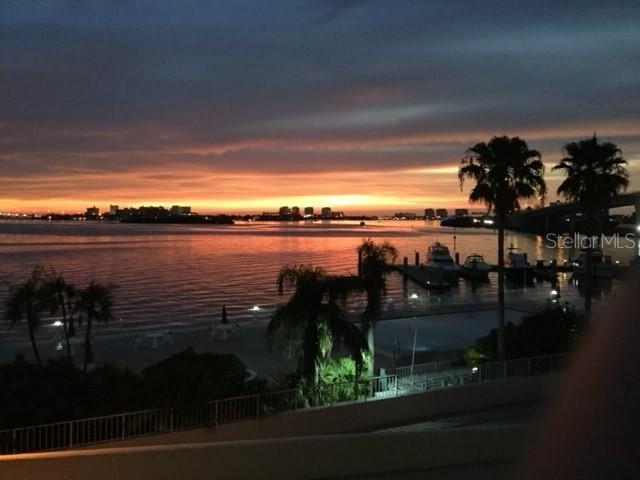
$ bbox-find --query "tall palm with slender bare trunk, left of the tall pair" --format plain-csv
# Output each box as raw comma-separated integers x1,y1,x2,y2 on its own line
458,136,547,359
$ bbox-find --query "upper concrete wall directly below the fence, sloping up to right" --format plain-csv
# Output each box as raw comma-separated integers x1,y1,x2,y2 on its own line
96,374,558,448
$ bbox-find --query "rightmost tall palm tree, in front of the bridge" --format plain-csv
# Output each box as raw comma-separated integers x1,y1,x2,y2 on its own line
553,133,629,318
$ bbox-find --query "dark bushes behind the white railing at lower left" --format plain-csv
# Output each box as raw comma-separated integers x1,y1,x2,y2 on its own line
0,349,255,429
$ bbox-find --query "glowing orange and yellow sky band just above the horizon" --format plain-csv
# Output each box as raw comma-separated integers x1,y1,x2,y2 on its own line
0,127,640,215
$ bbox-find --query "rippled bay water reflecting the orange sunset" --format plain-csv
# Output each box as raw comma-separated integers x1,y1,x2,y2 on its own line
0,221,632,331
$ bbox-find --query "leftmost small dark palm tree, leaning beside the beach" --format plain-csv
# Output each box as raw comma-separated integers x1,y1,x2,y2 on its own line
5,267,48,364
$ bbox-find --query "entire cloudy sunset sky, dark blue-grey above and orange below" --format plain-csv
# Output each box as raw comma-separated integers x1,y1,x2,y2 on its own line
0,0,640,214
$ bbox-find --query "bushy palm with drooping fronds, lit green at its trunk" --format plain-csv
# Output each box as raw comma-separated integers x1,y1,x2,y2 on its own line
266,265,367,387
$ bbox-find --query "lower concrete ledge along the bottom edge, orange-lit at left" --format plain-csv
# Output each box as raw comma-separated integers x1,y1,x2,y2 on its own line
0,428,529,480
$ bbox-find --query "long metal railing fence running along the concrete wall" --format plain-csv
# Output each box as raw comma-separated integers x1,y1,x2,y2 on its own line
0,355,565,454
